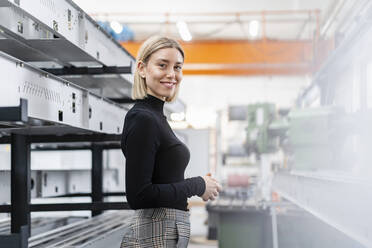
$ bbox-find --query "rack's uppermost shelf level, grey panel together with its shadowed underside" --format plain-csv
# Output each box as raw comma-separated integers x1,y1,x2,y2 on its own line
0,0,135,101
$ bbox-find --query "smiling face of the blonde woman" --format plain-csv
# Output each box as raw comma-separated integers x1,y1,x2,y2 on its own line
138,48,183,101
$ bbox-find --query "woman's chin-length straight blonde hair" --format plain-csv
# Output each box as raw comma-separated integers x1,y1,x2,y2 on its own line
132,36,185,102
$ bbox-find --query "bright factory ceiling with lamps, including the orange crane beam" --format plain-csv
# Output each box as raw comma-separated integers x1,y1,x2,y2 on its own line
75,0,363,75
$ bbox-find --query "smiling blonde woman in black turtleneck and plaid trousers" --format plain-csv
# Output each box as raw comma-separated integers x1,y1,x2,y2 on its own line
121,36,221,248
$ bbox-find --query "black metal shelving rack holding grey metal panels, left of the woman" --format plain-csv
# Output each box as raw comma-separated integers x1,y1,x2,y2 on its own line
0,0,185,248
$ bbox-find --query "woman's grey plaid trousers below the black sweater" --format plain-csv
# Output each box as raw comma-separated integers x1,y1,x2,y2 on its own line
121,208,190,248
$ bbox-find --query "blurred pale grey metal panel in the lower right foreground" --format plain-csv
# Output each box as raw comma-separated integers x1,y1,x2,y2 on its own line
273,172,372,247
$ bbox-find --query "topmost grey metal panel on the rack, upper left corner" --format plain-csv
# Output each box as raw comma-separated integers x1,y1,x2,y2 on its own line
0,0,134,66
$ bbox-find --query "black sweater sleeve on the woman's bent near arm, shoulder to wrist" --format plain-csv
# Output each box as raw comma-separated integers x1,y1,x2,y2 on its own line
122,111,205,209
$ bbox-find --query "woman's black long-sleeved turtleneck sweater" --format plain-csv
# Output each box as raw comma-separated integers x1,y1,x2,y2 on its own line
121,95,205,210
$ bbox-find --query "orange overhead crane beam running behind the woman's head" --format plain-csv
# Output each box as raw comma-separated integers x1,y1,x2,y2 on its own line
121,39,313,75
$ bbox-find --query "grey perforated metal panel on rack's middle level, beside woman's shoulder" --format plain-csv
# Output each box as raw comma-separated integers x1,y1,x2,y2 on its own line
0,53,126,134
